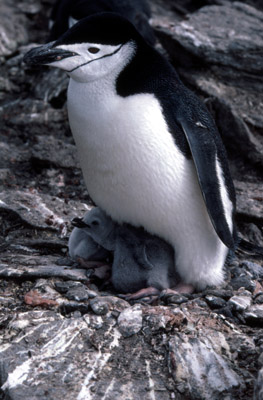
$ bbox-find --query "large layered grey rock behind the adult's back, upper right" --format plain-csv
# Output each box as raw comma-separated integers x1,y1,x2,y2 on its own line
157,2,263,166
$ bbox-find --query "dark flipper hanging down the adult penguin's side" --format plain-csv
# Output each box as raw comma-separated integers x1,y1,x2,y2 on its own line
177,117,235,249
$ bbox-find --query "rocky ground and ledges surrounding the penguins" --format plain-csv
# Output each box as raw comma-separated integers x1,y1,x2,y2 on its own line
0,0,263,400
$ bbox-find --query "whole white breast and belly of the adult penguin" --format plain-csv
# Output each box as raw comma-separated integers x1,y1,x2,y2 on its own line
68,79,231,290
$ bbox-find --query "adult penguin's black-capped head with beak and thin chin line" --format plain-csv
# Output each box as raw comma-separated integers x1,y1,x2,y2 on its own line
24,13,146,82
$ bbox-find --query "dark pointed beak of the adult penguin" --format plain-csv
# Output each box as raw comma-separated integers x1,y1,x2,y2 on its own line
23,42,77,66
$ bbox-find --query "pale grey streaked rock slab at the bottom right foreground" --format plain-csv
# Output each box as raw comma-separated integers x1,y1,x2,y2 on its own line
168,332,242,400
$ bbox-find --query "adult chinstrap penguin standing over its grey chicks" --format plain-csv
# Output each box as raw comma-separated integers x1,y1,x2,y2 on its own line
24,13,236,289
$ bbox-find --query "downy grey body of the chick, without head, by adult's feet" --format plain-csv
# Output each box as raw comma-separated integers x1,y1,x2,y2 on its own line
111,225,178,298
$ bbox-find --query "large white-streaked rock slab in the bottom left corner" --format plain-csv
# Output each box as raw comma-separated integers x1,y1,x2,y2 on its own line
0,311,120,400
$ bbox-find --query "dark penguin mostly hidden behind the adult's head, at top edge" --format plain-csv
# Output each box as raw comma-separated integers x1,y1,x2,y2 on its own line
49,0,155,45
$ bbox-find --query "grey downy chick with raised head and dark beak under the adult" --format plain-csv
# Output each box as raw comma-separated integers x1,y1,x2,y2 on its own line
69,207,178,297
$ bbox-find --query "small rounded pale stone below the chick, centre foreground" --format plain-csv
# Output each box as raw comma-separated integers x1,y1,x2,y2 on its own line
118,305,142,337
